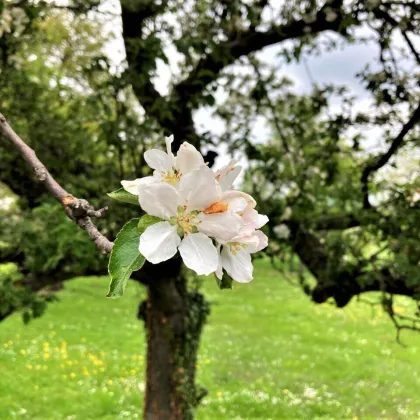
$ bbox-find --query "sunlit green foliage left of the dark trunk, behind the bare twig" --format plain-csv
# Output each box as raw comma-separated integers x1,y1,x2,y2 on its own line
0,7,153,308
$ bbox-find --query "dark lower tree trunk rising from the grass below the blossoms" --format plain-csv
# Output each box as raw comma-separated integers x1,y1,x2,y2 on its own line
140,258,209,420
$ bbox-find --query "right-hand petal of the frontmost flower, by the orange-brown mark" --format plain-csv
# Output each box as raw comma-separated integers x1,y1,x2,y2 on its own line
197,211,244,242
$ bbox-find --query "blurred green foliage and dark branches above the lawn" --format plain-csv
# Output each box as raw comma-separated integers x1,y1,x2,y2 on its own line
0,0,420,324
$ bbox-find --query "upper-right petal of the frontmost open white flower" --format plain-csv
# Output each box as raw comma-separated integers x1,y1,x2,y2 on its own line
177,166,222,211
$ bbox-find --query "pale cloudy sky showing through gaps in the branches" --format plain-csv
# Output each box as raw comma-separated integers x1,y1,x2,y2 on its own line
95,0,420,172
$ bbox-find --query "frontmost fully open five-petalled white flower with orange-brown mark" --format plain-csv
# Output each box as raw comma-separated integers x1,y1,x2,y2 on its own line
138,166,243,275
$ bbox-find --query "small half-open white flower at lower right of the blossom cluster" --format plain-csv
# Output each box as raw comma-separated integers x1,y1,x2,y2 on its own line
216,230,268,283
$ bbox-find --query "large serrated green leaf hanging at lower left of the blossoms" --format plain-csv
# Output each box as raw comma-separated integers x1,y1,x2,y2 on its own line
106,219,145,298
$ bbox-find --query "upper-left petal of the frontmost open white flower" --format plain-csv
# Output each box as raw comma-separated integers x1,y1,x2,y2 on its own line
139,181,179,220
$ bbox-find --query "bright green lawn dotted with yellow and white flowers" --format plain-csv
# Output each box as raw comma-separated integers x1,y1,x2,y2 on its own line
0,261,420,420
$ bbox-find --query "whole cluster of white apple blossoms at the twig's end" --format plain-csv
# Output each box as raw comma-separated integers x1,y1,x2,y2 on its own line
121,136,268,283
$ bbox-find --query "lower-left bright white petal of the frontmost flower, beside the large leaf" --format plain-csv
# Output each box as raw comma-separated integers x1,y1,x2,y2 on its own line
139,222,181,264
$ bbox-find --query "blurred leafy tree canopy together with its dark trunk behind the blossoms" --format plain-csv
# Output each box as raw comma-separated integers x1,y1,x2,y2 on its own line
0,0,420,418
